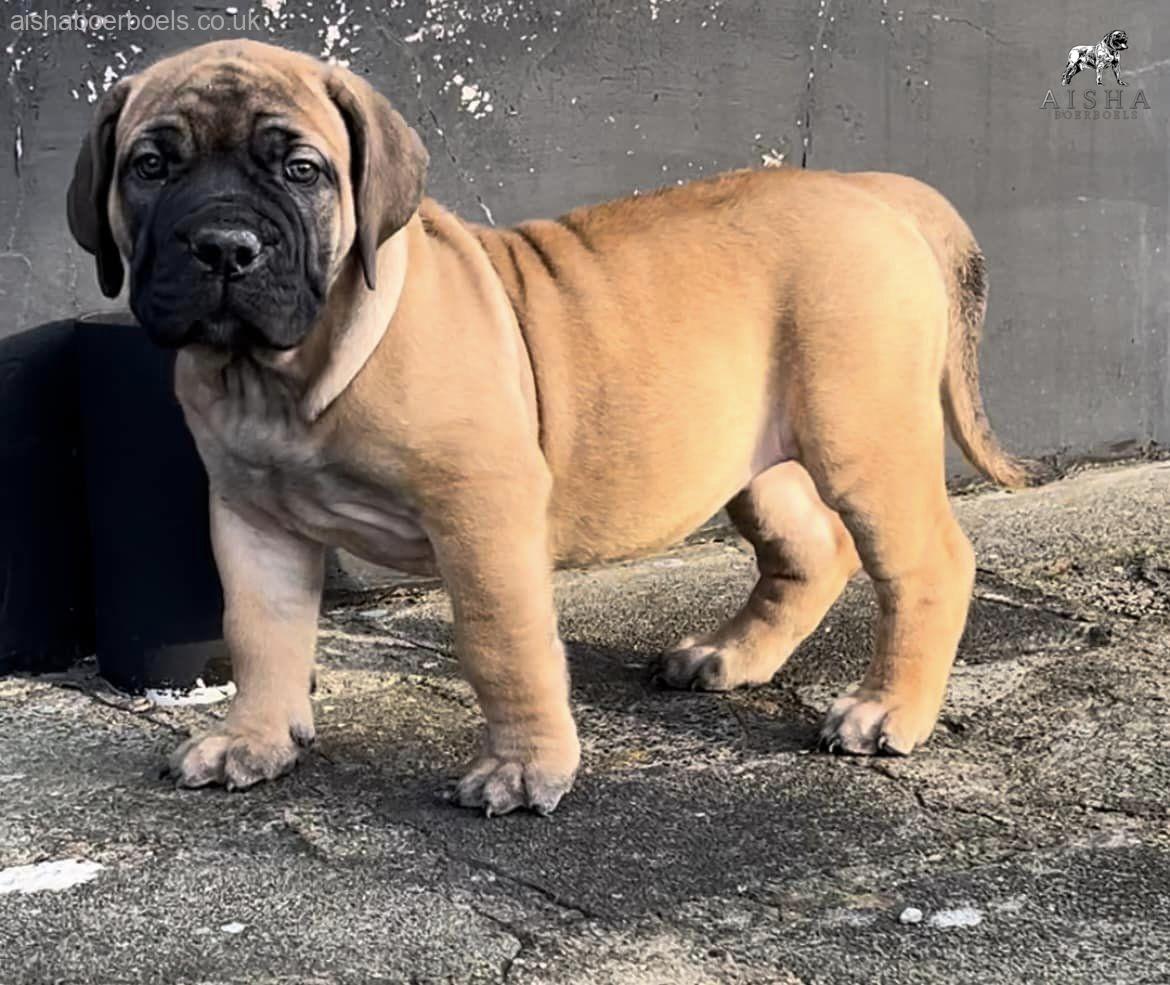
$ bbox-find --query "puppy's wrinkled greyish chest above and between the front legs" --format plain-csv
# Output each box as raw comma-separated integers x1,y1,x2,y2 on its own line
170,355,433,571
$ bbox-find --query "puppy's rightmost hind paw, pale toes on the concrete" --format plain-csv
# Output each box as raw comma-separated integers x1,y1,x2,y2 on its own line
820,689,938,756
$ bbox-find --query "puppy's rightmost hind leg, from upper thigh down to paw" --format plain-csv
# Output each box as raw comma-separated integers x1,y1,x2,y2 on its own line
787,228,975,753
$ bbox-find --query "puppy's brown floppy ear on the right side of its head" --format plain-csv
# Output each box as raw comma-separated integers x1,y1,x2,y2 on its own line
325,69,429,290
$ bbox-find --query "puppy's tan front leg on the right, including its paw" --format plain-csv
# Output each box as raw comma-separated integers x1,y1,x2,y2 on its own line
428,463,580,815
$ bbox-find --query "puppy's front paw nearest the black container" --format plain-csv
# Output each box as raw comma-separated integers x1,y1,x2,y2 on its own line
166,723,314,790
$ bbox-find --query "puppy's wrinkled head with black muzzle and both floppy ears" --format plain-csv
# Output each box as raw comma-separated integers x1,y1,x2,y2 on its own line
68,41,427,350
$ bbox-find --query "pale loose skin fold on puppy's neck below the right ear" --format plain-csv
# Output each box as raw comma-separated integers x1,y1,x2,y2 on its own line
255,218,419,423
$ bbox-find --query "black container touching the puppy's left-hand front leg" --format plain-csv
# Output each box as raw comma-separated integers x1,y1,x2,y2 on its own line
77,315,229,691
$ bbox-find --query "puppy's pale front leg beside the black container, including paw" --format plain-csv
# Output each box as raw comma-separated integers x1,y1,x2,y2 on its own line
170,491,324,790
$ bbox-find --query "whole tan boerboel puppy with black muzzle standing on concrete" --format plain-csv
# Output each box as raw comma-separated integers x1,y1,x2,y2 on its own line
69,41,1025,814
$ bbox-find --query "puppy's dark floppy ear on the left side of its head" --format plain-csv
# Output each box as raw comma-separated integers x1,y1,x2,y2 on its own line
66,78,130,297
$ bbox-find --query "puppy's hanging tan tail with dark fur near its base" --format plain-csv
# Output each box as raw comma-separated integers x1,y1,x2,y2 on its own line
940,245,1041,489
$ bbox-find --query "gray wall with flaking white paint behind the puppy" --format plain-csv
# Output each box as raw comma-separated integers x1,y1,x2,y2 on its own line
0,0,1170,467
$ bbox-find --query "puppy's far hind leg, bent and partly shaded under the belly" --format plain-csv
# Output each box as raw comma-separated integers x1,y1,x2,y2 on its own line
656,461,860,690
